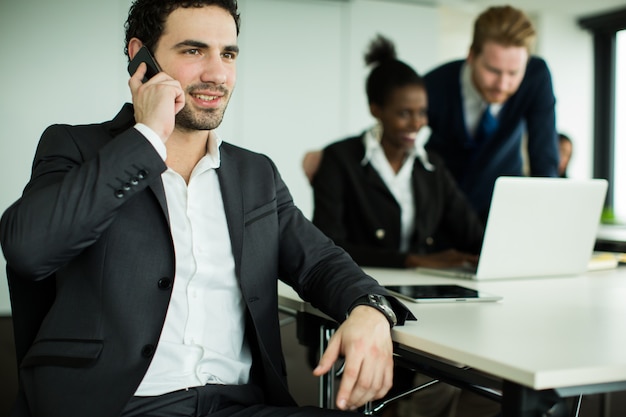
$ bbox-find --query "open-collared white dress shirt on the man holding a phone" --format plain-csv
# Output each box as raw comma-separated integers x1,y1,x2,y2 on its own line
135,125,252,396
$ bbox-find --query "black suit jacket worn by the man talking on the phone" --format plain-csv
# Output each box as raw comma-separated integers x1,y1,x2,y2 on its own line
0,105,410,417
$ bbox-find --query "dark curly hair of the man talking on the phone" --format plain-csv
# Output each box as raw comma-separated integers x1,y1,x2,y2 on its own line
124,0,241,56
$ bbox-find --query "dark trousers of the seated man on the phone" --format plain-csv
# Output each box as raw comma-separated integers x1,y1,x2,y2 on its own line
121,384,354,417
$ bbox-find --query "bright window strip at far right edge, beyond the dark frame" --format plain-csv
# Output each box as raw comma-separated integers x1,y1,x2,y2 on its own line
613,30,626,223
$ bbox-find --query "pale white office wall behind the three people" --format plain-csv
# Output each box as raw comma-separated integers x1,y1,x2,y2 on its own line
0,0,592,314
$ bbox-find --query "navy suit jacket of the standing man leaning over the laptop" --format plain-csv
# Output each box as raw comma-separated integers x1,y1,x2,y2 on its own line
424,57,559,219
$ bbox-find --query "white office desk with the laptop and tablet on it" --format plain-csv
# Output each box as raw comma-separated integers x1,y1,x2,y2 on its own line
279,268,626,417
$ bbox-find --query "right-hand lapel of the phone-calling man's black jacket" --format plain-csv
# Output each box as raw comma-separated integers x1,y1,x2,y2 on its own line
217,143,244,277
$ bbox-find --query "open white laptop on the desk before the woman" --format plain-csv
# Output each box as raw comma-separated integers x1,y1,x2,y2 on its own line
417,177,608,280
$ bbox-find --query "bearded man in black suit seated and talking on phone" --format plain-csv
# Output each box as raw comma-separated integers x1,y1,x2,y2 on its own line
0,0,410,417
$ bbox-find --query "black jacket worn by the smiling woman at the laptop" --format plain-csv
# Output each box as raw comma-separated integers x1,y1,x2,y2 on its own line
313,135,484,268
